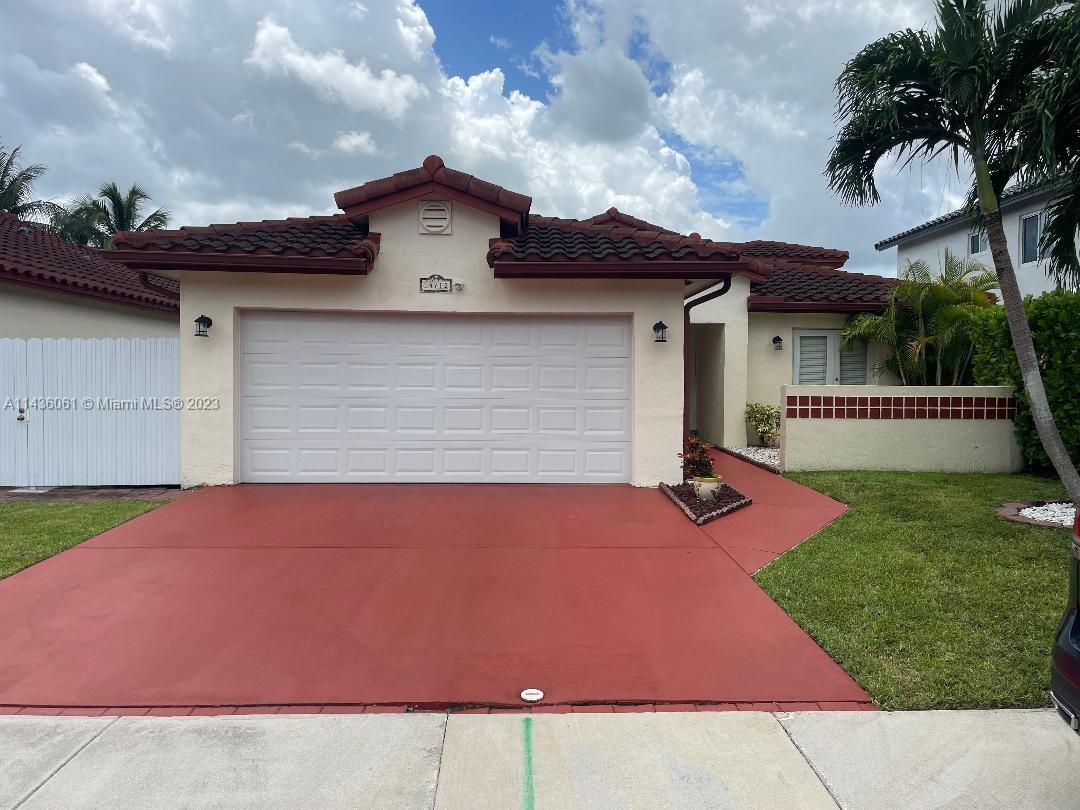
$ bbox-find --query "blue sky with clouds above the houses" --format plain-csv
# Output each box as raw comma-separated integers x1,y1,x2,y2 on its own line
0,0,964,272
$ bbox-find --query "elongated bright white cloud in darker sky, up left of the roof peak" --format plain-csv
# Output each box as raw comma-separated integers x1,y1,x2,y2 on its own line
245,12,428,121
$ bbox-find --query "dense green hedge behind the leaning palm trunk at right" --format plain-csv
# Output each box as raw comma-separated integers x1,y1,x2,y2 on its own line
972,289,1080,469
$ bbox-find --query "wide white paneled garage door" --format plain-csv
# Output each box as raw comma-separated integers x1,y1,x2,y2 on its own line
240,312,631,483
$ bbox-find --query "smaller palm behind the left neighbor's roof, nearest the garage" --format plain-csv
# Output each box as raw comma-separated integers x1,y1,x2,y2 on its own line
50,183,170,248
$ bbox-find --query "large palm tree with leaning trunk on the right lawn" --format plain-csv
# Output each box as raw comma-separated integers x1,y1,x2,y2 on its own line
825,0,1080,504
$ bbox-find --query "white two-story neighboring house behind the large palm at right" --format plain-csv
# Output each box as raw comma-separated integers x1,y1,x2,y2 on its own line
874,185,1071,295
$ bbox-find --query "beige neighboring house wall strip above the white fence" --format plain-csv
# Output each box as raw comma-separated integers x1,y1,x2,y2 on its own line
0,282,179,338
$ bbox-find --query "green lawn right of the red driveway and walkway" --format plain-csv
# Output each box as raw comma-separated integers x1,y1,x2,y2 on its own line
757,472,1070,708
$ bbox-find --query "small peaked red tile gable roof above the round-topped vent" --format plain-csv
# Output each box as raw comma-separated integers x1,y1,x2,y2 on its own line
334,154,532,219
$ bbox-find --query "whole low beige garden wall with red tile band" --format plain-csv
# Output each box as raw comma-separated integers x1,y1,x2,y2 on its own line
780,386,1023,472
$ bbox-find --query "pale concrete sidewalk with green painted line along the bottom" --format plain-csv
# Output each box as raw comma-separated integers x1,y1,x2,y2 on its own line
0,711,1080,808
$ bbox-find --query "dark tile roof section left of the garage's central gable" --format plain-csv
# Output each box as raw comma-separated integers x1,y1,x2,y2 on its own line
113,214,379,261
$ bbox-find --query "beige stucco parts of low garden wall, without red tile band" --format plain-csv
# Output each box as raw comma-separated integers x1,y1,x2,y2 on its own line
780,386,1024,473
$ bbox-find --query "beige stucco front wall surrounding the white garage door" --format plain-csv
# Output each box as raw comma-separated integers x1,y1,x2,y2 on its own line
180,202,684,486
